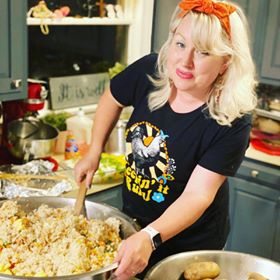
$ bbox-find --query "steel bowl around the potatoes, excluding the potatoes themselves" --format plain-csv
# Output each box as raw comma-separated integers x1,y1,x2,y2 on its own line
145,251,280,280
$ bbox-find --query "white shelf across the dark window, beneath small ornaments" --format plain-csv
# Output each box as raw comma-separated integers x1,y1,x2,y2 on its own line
27,17,132,25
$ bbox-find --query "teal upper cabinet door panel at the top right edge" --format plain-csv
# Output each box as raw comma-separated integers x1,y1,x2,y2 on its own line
261,0,280,84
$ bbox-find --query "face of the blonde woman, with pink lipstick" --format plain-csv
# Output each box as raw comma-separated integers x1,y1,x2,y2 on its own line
167,16,226,96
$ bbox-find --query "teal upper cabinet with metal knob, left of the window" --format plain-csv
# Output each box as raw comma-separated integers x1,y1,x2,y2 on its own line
0,0,27,101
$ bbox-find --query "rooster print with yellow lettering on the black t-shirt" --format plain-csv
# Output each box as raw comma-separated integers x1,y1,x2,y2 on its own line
125,121,176,203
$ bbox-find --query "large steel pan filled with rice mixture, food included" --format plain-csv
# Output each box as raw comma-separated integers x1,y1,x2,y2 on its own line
0,197,138,280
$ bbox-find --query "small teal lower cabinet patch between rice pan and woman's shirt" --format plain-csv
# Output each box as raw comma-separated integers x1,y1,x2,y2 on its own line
86,186,122,210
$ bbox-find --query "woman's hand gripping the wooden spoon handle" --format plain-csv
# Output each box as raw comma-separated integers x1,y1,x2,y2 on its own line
74,151,101,187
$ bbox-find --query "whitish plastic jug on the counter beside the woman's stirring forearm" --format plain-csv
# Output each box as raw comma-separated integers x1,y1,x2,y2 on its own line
66,108,93,145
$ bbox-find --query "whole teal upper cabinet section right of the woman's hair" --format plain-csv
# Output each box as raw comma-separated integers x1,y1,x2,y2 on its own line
236,0,280,85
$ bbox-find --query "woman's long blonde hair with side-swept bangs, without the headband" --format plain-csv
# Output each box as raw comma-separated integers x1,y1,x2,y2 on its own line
148,1,257,125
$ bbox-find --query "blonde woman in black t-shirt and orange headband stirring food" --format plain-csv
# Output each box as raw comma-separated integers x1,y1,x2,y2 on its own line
75,0,256,280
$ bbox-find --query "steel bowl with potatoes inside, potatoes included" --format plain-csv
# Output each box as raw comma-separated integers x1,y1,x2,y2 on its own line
145,251,280,280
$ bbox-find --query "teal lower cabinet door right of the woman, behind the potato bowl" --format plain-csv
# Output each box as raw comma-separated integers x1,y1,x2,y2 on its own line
227,178,280,261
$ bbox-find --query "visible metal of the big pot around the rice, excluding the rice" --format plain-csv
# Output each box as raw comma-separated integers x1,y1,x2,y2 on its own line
0,197,139,280
